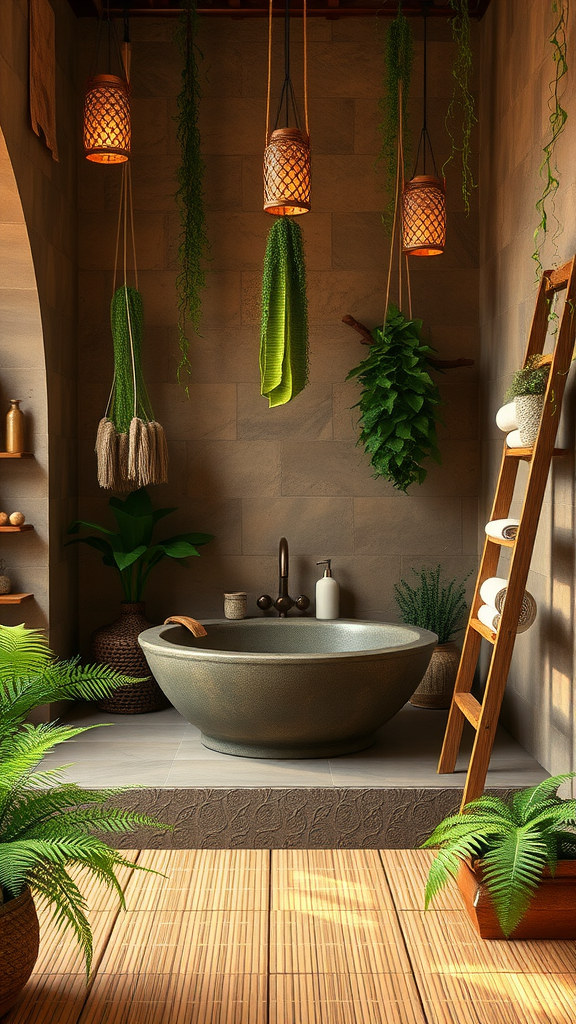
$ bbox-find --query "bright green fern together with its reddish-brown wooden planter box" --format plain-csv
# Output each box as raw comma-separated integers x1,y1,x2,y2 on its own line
423,772,576,939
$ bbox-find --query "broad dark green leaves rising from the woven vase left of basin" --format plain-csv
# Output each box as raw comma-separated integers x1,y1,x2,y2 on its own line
68,487,213,601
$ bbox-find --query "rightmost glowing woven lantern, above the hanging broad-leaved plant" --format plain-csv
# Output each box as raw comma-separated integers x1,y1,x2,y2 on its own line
402,174,446,256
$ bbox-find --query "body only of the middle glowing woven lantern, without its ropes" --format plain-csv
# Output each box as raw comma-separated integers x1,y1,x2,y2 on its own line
264,128,311,217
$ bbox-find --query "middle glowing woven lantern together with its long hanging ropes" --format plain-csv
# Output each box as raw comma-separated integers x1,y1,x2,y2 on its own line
264,0,311,217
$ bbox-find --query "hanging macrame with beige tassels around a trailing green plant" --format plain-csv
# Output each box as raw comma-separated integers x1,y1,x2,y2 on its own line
95,164,168,490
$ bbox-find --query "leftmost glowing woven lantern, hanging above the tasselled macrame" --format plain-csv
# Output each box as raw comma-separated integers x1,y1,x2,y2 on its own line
84,75,131,164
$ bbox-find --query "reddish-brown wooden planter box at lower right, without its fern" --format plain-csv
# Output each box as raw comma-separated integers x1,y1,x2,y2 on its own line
456,860,576,939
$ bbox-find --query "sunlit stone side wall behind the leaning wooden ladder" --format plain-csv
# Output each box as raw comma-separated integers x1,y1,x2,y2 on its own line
480,0,576,786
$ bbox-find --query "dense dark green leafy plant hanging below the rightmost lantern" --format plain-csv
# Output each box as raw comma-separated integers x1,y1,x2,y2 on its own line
346,303,441,492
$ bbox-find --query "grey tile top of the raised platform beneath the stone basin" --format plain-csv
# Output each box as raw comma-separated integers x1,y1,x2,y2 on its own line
44,703,547,788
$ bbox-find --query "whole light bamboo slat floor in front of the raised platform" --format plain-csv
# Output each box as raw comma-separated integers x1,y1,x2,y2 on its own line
3,850,576,1024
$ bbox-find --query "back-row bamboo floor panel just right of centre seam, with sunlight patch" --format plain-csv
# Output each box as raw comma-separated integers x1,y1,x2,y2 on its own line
271,850,394,911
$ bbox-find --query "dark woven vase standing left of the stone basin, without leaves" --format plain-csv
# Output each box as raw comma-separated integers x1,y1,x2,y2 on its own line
92,601,170,715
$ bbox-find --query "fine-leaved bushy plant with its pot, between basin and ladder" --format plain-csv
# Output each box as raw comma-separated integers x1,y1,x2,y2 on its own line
394,565,467,708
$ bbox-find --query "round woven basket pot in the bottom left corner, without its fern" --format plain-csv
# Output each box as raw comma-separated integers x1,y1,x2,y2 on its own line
0,886,40,1017
